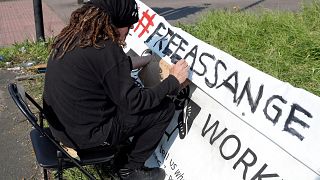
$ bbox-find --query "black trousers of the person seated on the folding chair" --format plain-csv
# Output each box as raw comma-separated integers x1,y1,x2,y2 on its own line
108,98,175,168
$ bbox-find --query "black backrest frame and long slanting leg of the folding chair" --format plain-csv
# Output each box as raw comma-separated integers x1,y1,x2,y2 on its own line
8,83,95,179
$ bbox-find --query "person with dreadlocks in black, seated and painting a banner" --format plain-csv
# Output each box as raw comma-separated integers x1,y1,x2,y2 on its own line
43,0,189,180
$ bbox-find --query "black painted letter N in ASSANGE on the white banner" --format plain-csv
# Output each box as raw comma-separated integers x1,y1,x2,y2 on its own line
237,77,263,113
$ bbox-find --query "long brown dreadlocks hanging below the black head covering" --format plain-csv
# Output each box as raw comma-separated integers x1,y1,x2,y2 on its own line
51,5,121,59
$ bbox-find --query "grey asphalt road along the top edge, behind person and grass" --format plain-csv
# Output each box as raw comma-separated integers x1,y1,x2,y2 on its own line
44,0,312,25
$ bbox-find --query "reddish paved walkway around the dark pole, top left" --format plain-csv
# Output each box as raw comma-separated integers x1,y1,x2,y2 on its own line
0,0,65,47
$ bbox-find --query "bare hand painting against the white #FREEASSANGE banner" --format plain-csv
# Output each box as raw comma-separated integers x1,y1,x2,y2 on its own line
170,59,189,84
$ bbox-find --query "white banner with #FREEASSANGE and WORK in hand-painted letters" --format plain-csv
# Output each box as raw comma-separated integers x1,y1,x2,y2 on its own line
127,0,320,180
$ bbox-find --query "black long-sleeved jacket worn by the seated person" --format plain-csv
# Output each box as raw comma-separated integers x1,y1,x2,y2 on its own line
44,40,179,149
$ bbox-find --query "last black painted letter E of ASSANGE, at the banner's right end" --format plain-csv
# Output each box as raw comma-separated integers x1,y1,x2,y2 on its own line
283,104,312,141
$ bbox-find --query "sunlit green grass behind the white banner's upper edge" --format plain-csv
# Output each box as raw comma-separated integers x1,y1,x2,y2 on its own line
179,1,320,96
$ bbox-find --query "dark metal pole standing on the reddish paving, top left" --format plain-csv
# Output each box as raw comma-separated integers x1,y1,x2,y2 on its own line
33,0,45,41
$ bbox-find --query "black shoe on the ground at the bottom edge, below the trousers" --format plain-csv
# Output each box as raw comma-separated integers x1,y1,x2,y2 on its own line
119,167,166,180
